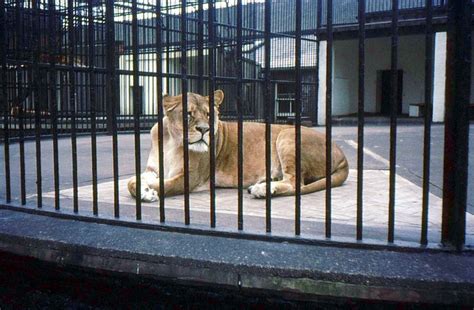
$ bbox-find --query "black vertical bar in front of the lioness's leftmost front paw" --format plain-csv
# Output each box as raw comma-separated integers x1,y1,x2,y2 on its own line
132,0,142,221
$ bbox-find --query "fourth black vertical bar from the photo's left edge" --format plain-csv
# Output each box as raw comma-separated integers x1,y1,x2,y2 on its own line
48,0,60,210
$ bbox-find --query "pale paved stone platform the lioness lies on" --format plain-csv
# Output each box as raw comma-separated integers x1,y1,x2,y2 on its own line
38,170,474,243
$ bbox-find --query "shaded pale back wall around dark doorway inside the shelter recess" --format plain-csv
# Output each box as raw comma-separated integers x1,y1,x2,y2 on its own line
330,35,425,115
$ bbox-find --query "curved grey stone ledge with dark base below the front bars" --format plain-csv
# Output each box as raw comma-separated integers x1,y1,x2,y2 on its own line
0,205,474,309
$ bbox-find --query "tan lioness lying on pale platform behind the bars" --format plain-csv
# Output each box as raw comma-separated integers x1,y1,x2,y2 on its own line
128,90,349,202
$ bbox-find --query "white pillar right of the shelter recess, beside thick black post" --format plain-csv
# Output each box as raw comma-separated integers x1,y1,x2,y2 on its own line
433,32,448,122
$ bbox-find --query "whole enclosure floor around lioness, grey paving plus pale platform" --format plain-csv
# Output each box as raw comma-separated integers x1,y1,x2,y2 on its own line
0,126,474,245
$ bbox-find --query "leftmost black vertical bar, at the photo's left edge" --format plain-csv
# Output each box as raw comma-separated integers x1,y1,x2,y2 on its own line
0,0,11,203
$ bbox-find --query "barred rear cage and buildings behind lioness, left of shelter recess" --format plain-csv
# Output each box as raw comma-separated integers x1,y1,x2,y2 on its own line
0,1,316,132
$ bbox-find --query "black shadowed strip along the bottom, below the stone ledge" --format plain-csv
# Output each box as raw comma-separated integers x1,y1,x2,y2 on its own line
0,252,400,309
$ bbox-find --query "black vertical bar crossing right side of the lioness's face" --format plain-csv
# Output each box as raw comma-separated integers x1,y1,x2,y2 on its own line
208,0,216,228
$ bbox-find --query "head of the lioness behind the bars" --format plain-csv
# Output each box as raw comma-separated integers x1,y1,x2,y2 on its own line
163,90,224,152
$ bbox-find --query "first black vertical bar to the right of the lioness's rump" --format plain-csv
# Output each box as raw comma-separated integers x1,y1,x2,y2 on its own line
356,0,366,240
